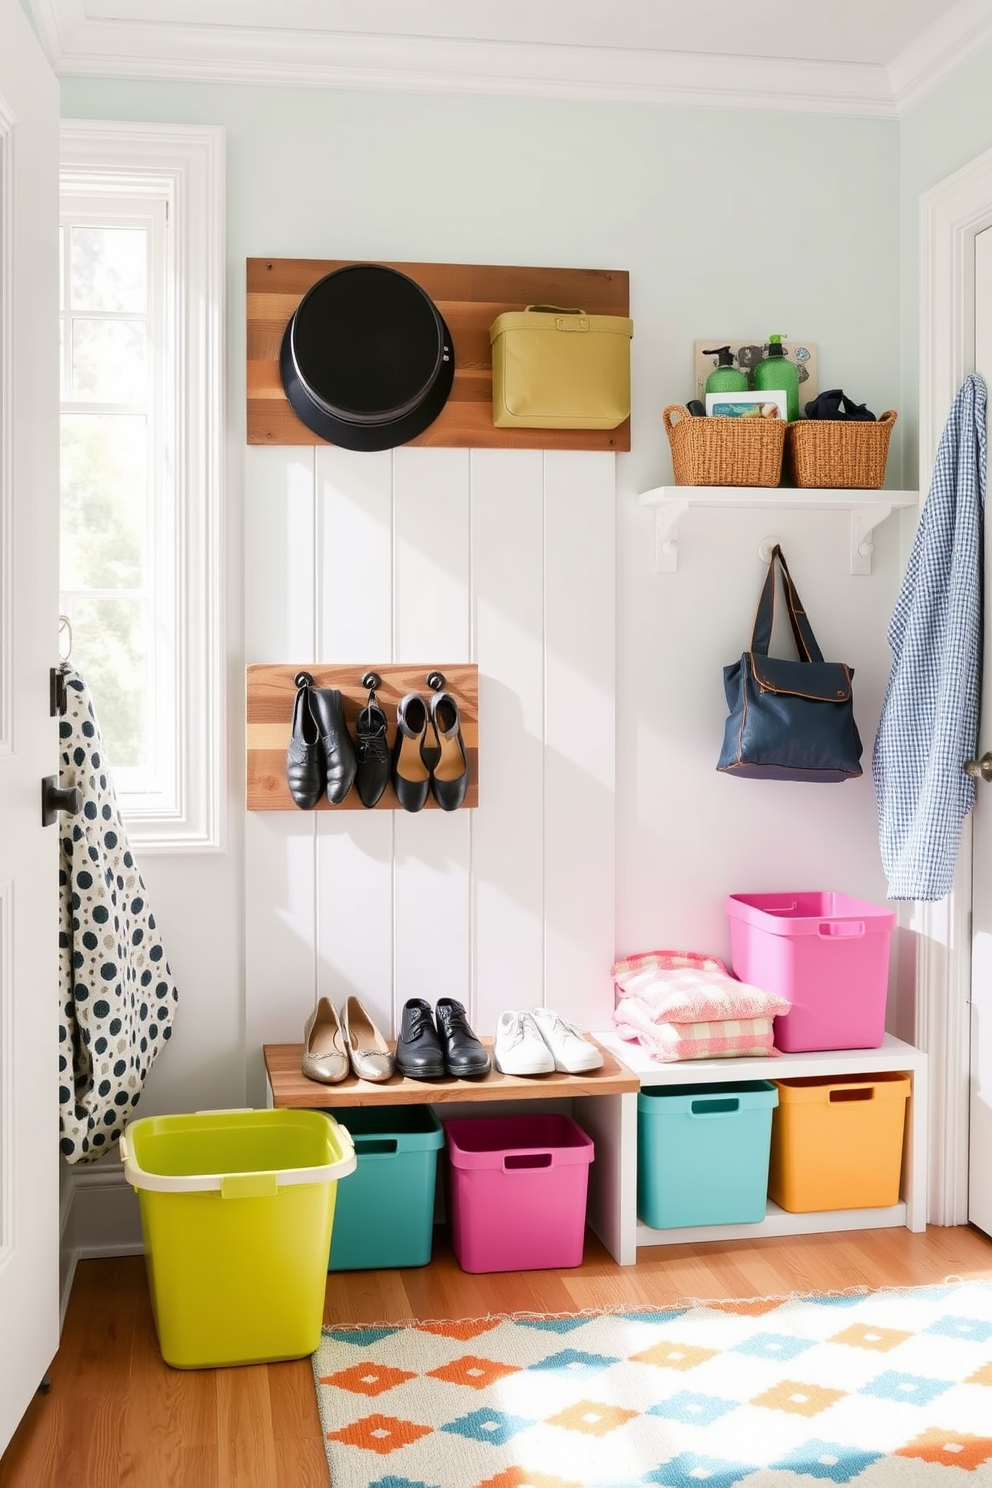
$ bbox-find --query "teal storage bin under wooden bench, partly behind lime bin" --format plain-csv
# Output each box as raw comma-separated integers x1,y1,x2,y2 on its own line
327,1106,445,1271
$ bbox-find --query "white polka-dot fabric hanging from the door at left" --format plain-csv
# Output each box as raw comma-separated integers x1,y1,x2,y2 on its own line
58,667,178,1164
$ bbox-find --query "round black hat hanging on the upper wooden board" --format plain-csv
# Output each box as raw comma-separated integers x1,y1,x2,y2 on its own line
280,263,455,449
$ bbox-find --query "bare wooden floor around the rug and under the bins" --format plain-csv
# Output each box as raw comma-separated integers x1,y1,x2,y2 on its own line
0,1226,992,1488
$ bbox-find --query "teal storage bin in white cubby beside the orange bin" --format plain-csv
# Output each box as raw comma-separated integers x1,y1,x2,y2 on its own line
637,1080,778,1229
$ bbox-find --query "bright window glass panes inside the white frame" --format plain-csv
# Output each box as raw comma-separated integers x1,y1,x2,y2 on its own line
59,195,171,815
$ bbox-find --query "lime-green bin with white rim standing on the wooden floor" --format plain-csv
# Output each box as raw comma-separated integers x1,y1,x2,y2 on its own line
120,1110,355,1369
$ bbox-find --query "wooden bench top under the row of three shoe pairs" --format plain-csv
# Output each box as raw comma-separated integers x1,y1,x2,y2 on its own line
262,1039,641,1109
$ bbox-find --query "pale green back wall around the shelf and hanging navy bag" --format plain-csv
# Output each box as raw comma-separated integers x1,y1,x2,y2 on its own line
54,82,901,970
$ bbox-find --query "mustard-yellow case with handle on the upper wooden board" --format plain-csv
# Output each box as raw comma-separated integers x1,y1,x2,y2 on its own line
489,305,634,429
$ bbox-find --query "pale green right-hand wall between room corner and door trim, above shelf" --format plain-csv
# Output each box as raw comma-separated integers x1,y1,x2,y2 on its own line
901,48,992,484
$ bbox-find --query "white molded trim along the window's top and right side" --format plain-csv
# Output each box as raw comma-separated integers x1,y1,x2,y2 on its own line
59,119,226,853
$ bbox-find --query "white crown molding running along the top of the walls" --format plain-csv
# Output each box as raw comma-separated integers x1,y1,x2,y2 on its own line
28,0,992,119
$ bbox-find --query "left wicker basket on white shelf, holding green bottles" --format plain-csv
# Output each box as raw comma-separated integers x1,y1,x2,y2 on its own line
662,403,785,485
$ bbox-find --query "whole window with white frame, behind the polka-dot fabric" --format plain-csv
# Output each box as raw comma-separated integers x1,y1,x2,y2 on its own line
59,122,223,851
